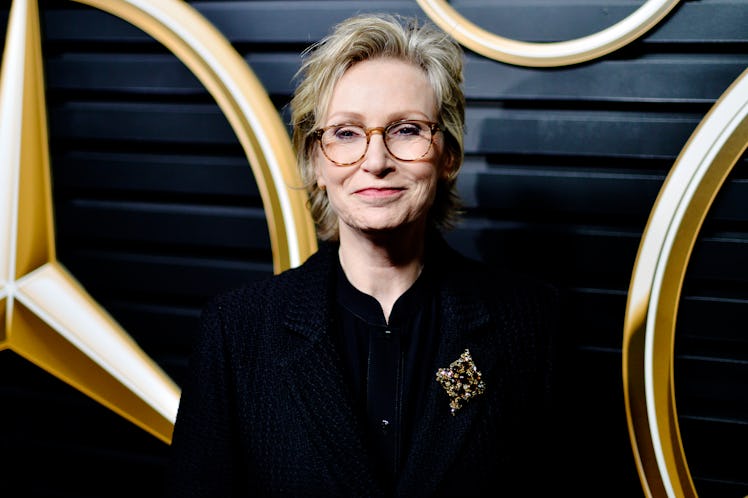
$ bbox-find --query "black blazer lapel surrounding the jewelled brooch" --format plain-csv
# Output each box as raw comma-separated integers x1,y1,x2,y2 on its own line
396,270,497,496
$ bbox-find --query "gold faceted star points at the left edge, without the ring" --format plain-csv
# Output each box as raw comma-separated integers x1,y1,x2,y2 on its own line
0,1,179,441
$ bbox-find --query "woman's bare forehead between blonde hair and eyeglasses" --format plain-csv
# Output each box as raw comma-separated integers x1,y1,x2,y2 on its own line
325,58,437,124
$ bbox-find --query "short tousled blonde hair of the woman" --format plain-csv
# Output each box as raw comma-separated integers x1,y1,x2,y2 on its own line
291,14,465,240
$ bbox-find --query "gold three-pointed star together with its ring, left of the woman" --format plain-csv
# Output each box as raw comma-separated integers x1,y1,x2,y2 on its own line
0,0,317,442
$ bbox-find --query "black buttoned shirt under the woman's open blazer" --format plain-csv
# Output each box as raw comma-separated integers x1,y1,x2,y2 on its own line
336,262,439,492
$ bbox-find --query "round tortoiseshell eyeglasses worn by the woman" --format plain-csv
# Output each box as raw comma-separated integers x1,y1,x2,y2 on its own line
314,119,441,166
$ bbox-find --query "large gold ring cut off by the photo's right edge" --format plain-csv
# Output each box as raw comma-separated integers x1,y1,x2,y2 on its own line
622,70,748,498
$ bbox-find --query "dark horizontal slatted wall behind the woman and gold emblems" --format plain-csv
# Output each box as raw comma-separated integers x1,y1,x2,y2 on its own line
0,0,748,497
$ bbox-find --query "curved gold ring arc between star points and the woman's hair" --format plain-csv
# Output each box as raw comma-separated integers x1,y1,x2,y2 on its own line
76,0,317,273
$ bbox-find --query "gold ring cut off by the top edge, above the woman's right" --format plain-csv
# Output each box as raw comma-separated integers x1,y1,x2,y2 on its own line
417,0,678,67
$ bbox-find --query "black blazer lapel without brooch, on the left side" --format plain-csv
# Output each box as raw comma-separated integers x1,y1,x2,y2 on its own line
279,247,381,496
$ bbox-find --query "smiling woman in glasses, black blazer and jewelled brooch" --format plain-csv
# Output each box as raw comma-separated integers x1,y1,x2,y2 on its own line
172,15,554,498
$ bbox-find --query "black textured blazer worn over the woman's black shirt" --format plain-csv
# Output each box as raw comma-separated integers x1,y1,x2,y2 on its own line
169,239,556,498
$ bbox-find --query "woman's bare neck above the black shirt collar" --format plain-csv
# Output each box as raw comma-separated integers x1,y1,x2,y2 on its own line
339,224,425,321
